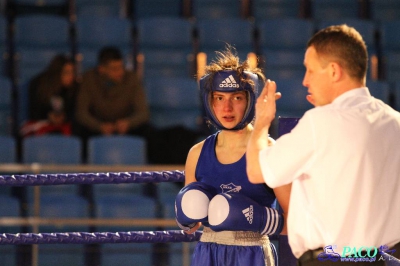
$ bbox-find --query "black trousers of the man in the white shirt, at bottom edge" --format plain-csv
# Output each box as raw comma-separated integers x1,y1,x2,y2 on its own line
297,242,400,266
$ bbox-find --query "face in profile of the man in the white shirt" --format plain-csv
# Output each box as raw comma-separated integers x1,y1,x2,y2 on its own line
303,46,334,106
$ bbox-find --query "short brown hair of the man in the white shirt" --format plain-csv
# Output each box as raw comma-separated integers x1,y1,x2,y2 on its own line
307,24,368,80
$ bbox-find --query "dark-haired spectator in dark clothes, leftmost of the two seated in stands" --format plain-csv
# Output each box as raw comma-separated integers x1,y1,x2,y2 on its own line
20,54,78,137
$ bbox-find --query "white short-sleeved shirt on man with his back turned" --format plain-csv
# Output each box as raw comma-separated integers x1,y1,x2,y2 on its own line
260,88,400,257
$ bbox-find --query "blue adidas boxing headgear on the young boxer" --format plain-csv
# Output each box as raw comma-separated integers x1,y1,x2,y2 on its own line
200,70,259,130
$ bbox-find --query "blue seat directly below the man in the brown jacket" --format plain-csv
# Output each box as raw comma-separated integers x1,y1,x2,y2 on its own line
88,135,147,165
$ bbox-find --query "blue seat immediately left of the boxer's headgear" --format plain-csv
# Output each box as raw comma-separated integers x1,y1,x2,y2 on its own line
145,77,201,129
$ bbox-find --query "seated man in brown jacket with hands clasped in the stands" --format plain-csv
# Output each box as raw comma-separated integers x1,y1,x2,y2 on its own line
76,47,149,138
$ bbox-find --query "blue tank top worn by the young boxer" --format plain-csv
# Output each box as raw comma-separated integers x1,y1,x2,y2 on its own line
196,132,275,207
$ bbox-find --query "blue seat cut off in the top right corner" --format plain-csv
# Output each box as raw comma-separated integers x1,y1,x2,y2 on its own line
370,0,400,21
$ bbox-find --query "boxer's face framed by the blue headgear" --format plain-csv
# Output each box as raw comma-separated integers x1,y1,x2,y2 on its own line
212,91,247,129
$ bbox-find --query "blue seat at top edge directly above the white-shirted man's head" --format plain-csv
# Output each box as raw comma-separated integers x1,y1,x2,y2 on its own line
311,0,359,20
